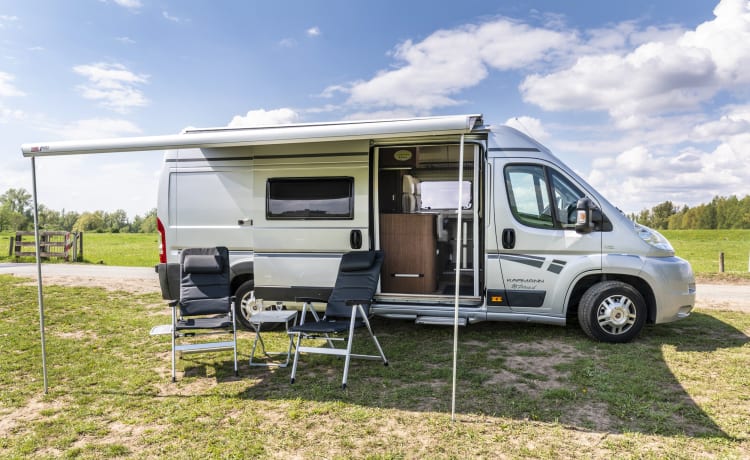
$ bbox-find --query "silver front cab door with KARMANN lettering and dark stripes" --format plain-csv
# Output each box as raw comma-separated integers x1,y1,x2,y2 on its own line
490,158,602,315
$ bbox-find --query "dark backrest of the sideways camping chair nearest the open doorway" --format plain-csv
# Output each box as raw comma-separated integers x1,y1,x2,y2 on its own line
325,251,384,318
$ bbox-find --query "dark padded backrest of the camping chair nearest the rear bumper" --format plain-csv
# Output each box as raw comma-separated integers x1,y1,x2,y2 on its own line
179,247,231,316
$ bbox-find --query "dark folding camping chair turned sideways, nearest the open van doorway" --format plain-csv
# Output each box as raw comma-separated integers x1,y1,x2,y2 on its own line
289,251,388,389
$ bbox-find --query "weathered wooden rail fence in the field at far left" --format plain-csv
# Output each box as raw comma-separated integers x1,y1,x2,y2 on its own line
9,232,83,262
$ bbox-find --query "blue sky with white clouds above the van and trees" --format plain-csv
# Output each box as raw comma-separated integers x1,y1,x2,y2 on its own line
0,0,750,217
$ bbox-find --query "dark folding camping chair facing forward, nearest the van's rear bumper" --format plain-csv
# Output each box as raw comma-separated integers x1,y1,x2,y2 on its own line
170,247,238,382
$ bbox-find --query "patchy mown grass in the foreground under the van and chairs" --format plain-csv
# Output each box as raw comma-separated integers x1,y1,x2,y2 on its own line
0,276,750,459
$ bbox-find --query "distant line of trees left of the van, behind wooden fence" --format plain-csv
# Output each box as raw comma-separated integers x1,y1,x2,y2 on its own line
0,188,156,233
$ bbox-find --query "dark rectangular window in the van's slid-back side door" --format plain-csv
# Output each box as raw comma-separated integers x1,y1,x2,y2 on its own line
266,177,354,220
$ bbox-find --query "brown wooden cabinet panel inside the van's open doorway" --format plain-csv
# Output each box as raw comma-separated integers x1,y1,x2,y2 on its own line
380,214,437,294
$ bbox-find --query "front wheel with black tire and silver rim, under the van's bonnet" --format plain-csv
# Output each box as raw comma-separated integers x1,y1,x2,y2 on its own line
578,281,646,343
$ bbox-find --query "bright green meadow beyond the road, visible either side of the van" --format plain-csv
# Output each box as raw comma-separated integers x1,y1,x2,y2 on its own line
0,230,750,279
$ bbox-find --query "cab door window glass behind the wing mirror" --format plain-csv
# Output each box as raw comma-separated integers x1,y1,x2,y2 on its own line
505,165,584,229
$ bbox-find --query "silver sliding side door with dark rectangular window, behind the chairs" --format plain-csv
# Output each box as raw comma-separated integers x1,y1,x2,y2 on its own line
252,142,370,301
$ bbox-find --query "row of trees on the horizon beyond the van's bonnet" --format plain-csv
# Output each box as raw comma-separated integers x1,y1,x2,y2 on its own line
628,195,750,230
